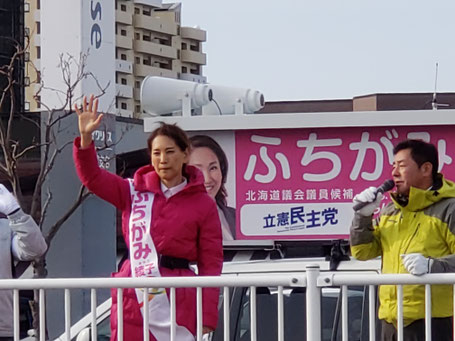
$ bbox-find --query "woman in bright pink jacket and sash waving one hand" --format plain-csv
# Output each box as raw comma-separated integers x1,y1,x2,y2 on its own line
73,96,223,341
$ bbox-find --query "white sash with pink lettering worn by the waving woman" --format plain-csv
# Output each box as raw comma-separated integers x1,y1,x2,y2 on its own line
128,179,194,341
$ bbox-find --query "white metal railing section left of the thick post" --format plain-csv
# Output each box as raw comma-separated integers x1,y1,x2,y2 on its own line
0,274,306,341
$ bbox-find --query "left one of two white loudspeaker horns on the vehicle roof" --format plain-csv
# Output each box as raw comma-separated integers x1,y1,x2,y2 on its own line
141,76,212,116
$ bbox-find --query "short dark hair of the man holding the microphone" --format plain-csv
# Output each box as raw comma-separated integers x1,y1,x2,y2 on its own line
393,140,439,181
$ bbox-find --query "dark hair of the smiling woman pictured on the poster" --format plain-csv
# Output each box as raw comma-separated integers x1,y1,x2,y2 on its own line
190,135,228,206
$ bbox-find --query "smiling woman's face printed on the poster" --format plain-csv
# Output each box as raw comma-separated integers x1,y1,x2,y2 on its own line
189,147,223,199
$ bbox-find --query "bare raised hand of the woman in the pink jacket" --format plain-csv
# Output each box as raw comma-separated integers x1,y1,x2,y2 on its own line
74,95,103,149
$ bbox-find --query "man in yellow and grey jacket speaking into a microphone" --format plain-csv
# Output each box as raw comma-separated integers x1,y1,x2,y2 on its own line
350,140,455,341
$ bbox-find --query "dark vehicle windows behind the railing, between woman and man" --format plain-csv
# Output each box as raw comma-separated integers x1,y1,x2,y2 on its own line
213,287,378,341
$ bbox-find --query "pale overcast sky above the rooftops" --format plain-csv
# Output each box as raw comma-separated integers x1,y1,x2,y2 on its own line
179,0,455,101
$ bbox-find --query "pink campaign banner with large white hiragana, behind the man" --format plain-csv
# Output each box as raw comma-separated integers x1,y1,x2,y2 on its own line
235,126,455,239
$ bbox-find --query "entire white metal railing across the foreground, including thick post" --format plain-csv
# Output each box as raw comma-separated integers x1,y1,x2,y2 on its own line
0,265,455,341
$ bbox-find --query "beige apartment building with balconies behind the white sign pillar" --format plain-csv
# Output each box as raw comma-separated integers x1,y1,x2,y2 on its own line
25,0,206,117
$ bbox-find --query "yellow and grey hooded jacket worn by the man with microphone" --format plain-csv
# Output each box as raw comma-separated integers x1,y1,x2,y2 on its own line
350,174,455,326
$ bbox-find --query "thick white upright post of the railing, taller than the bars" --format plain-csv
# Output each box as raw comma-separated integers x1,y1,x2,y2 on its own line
306,264,321,341
